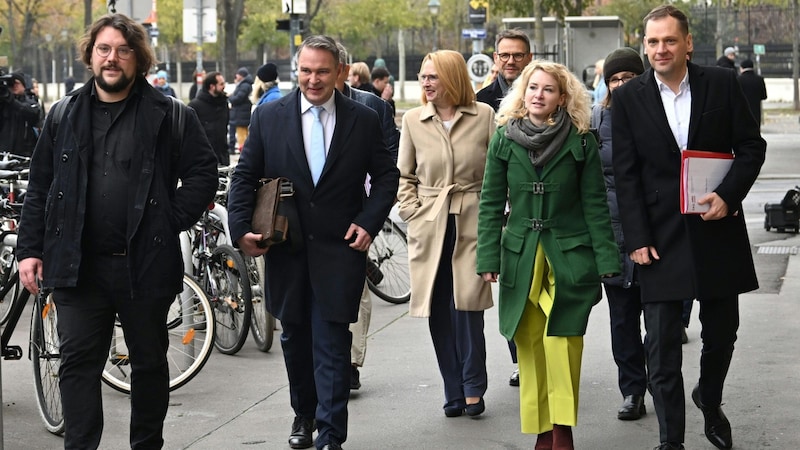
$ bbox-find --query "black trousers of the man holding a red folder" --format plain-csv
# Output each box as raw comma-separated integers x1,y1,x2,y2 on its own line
644,296,739,443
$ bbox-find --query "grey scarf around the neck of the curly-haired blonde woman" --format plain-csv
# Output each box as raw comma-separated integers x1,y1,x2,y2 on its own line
505,106,572,167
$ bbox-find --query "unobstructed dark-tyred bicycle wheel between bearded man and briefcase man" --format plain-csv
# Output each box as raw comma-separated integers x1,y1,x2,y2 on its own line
206,245,253,355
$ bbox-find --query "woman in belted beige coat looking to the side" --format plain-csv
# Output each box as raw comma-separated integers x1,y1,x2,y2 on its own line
397,50,495,417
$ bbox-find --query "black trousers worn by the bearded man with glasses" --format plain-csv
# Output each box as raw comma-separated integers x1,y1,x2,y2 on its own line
53,255,174,450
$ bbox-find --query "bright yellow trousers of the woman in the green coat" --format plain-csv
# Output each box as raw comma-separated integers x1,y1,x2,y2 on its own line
514,245,583,434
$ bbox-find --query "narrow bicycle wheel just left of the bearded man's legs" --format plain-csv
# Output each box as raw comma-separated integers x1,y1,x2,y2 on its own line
30,291,64,435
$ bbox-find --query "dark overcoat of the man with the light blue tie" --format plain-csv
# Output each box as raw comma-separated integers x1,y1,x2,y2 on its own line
228,89,400,322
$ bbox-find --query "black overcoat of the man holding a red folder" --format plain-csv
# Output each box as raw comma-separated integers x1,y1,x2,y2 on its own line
612,63,766,302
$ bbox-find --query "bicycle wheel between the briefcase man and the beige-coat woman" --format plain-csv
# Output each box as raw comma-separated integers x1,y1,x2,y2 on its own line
367,218,411,305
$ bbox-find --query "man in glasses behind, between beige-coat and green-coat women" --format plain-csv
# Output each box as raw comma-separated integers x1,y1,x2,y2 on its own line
477,28,533,386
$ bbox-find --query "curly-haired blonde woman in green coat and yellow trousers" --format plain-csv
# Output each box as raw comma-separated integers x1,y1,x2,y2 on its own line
477,61,620,450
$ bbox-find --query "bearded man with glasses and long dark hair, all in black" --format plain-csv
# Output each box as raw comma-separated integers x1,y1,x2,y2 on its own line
17,14,217,449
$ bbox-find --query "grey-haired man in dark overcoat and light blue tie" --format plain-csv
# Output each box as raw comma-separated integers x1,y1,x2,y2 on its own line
228,36,399,449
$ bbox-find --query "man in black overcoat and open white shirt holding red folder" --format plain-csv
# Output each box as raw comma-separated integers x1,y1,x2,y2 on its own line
612,5,766,450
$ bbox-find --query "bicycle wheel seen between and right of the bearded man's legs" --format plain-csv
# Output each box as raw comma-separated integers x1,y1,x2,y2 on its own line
103,275,215,394
